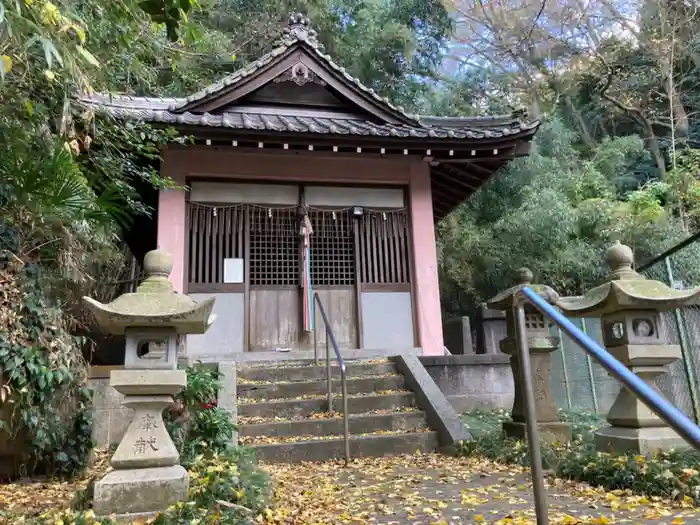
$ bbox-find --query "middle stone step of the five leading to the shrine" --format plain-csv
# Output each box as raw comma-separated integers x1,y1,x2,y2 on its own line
238,392,415,418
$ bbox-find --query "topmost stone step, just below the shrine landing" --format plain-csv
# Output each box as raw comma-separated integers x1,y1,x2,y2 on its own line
237,360,397,383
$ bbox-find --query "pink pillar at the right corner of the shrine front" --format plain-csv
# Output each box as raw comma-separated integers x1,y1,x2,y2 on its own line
409,162,444,355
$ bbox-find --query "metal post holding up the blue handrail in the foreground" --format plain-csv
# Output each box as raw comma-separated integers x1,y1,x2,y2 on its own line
516,302,549,525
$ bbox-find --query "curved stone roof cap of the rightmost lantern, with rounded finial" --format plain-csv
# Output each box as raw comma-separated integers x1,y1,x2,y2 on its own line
557,241,700,316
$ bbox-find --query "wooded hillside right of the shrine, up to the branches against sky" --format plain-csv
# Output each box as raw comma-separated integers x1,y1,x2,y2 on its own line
432,0,700,314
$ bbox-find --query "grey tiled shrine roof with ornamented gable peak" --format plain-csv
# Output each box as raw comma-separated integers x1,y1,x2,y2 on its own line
78,15,539,140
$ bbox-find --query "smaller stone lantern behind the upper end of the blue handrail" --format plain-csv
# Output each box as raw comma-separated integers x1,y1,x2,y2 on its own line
487,268,571,443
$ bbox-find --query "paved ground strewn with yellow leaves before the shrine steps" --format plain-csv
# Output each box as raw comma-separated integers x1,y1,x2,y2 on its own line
259,454,700,525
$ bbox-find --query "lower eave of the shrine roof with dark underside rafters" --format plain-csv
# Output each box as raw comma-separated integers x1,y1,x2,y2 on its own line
79,101,540,222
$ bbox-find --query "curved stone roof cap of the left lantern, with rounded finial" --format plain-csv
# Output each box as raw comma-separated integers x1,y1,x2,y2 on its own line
83,250,216,334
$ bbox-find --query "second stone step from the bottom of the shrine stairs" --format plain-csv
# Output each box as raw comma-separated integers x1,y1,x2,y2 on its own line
238,411,427,438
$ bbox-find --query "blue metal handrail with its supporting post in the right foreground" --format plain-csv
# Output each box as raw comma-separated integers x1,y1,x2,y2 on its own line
514,286,700,525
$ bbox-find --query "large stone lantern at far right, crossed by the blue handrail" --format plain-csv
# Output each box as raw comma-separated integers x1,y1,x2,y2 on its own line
557,241,700,454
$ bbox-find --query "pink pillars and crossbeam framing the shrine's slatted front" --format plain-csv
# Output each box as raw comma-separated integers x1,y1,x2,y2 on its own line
158,147,443,355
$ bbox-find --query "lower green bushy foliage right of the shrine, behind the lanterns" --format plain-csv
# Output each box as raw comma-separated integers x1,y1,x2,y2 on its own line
438,118,700,313
